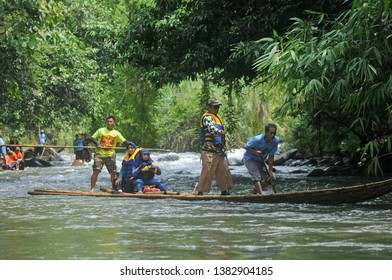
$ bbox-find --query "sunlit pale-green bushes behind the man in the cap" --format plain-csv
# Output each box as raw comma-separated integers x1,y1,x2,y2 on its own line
156,76,287,151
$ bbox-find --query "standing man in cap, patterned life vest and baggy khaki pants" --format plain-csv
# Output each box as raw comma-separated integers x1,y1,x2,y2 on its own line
198,99,233,195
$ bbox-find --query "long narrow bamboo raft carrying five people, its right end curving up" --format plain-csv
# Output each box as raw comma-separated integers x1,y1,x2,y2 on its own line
28,179,392,205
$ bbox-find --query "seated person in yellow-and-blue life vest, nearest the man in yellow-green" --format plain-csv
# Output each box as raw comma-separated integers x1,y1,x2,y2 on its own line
115,142,141,192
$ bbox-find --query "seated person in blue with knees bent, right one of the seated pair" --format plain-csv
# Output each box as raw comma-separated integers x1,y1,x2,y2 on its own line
132,149,167,193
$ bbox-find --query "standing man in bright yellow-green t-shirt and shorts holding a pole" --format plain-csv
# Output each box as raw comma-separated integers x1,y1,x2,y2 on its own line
90,116,130,192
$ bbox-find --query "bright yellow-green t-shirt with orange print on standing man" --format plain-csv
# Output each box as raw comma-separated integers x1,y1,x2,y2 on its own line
92,127,126,157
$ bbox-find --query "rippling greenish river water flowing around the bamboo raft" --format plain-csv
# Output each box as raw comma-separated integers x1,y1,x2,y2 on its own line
0,151,392,260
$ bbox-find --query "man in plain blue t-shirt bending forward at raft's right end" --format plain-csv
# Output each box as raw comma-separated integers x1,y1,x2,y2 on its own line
242,124,279,194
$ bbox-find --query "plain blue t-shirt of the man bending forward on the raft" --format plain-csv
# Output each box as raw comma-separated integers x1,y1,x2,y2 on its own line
242,133,279,162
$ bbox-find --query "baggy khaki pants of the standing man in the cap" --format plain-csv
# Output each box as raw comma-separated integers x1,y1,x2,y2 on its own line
199,150,233,192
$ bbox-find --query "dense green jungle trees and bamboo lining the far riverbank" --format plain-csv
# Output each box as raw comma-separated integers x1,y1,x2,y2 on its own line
0,0,392,175
